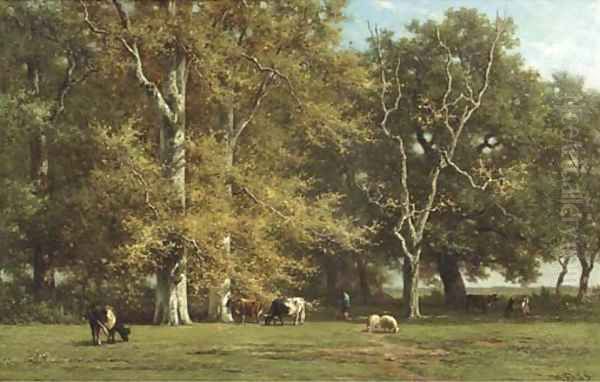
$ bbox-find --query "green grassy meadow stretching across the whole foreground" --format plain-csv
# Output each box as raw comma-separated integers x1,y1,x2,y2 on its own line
0,314,600,381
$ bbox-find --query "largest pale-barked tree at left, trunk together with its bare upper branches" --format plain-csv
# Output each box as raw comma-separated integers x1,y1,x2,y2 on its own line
81,0,193,325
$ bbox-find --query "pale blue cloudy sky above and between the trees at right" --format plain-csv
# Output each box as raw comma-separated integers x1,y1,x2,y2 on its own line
343,0,600,286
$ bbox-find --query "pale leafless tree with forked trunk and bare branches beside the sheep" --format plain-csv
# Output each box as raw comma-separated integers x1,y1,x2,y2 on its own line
364,10,510,318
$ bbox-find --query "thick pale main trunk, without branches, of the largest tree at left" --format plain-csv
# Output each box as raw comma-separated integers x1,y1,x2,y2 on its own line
154,44,192,325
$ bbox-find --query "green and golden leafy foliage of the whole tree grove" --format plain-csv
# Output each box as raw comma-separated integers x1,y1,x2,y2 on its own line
0,0,600,322
